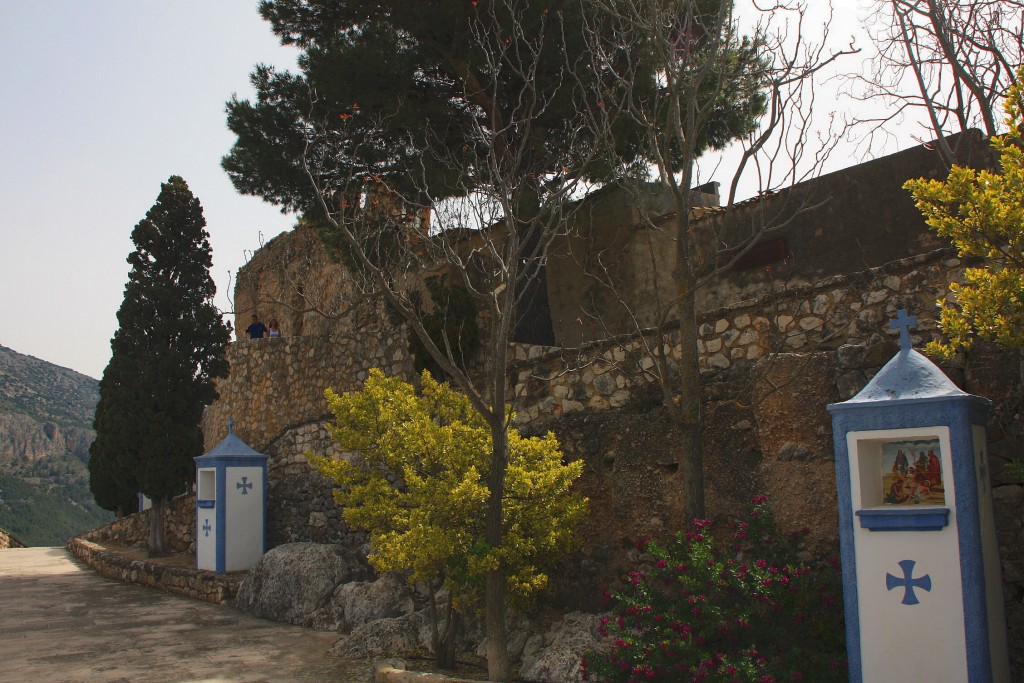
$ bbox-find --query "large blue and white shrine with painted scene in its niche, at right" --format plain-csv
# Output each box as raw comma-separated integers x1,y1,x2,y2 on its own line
828,310,1010,683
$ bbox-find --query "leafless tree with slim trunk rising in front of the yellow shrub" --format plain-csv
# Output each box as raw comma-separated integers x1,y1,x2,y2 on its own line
280,5,626,681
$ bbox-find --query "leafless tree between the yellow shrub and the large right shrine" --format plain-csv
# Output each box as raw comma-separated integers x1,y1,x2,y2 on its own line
577,0,856,518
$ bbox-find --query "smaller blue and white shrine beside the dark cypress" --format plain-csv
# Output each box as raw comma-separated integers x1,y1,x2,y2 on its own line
196,420,266,572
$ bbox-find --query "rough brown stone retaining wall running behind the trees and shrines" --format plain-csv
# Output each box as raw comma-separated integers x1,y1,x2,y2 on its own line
195,228,1024,663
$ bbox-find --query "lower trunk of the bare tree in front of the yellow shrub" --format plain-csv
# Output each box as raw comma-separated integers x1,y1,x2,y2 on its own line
484,423,512,681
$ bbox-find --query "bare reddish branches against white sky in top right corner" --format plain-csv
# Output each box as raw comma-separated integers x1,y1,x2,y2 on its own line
846,0,1024,165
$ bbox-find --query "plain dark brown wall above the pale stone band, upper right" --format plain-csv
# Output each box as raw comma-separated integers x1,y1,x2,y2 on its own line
692,131,994,312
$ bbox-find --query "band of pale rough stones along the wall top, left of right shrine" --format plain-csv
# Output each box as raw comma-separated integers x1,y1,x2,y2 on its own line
509,250,963,424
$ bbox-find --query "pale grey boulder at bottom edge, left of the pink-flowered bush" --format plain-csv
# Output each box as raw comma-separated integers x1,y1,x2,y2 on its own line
519,612,601,683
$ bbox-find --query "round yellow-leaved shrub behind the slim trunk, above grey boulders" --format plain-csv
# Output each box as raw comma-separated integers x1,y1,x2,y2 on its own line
307,370,586,605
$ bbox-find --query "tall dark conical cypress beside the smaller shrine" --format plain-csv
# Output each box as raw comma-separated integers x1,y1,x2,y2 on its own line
94,176,229,556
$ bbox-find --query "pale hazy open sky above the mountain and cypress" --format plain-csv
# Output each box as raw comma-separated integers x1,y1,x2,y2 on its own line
0,0,880,379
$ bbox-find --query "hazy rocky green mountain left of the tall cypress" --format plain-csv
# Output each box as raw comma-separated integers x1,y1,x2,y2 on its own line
0,346,114,546
